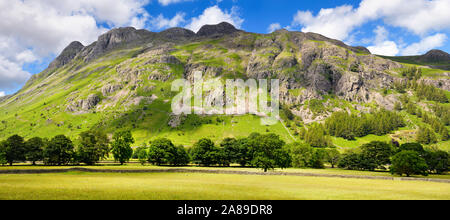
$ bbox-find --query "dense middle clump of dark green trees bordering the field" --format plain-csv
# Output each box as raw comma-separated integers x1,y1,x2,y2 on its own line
134,133,291,171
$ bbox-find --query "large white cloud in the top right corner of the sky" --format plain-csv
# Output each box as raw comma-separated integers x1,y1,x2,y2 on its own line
292,0,450,40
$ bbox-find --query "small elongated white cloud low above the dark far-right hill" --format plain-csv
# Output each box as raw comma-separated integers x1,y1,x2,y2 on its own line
402,34,447,56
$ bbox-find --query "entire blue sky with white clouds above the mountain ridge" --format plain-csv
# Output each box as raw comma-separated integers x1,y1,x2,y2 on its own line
0,0,450,96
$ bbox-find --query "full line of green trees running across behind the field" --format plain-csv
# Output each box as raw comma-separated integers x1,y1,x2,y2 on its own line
0,131,449,176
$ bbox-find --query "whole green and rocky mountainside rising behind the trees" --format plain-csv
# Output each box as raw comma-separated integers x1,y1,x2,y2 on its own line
0,23,450,149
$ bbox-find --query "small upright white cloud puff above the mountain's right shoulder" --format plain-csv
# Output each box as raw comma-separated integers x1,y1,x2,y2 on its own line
367,26,399,56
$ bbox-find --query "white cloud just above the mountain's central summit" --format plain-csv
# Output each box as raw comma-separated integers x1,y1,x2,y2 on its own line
186,5,244,32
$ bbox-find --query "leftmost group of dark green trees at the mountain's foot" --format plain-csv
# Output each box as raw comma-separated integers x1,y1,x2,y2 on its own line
0,131,134,166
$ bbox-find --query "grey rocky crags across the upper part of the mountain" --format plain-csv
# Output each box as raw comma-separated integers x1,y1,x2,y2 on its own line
0,23,414,111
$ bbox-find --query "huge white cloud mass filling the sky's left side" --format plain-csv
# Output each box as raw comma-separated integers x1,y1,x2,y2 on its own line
0,0,149,93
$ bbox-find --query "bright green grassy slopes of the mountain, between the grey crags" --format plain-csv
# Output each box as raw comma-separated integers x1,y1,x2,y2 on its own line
0,33,450,149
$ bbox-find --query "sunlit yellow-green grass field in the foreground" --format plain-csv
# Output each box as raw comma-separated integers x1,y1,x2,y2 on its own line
0,172,450,200
